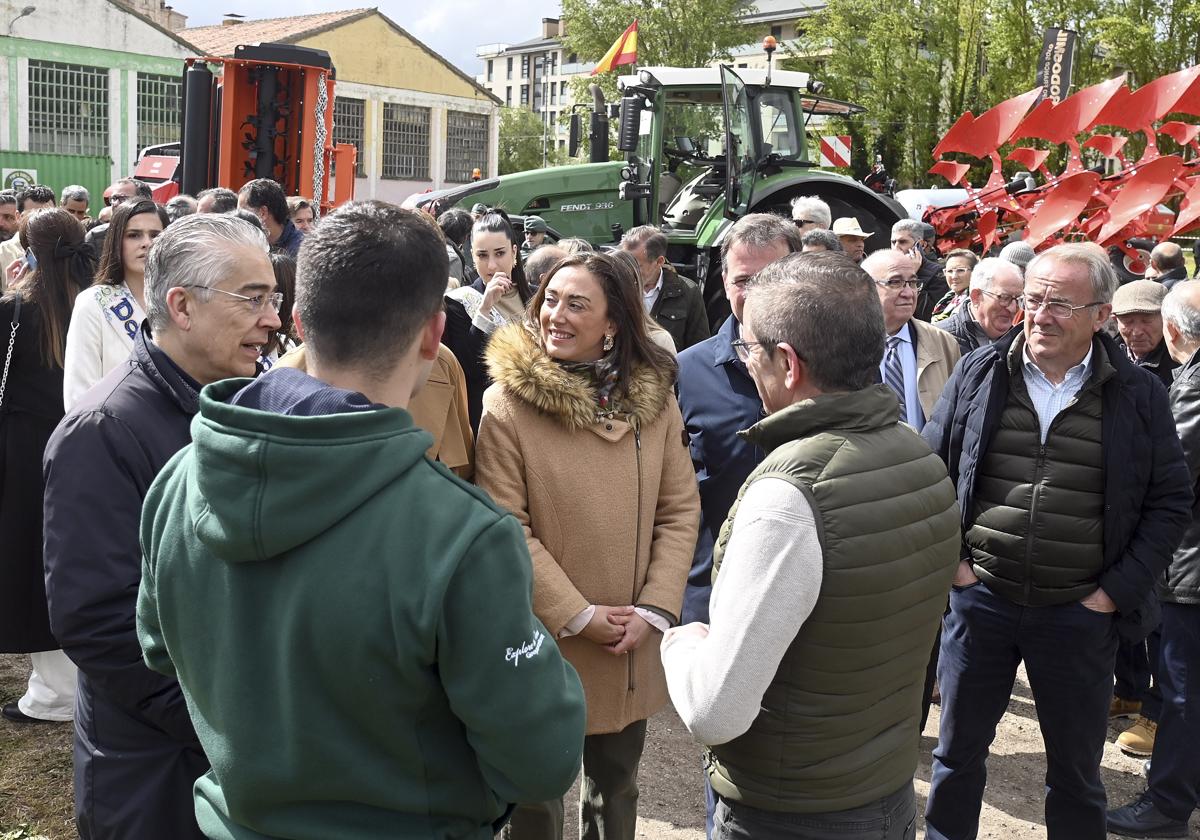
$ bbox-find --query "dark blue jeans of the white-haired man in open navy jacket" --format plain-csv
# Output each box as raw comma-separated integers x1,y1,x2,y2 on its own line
925,582,1117,840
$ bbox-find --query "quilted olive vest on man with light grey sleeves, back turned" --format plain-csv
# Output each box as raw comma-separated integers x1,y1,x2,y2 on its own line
708,385,960,814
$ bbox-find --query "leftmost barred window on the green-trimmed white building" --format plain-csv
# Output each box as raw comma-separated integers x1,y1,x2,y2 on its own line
29,59,109,157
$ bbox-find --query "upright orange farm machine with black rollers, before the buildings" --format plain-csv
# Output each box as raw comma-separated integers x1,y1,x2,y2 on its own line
134,43,358,212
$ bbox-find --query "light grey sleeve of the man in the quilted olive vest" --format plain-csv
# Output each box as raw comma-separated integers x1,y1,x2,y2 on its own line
661,478,824,745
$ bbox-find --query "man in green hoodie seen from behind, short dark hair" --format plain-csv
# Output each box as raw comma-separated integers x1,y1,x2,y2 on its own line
138,203,584,840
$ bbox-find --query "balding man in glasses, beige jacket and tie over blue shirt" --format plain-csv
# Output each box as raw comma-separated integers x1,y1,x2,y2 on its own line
863,248,960,432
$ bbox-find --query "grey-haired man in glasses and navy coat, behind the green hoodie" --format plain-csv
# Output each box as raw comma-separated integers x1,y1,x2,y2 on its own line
43,215,280,840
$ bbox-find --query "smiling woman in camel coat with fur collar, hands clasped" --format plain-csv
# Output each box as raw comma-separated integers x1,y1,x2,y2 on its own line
475,253,700,840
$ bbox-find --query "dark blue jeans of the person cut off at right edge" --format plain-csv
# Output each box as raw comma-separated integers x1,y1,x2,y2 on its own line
1150,602,1200,821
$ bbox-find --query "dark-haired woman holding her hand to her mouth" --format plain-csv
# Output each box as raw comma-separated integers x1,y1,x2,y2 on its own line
442,210,533,432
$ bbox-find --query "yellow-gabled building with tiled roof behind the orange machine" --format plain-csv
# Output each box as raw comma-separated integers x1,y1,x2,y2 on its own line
180,8,500,203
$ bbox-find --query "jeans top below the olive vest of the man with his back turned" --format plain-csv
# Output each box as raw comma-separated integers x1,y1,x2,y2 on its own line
713,784,917,840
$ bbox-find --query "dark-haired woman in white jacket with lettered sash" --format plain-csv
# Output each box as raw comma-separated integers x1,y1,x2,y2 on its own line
62,199,169,410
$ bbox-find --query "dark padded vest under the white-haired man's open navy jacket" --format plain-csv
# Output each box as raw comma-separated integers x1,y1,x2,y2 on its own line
964,337,1115,607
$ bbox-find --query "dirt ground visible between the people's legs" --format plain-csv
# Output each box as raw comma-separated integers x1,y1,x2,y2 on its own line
0,656,1200,840
